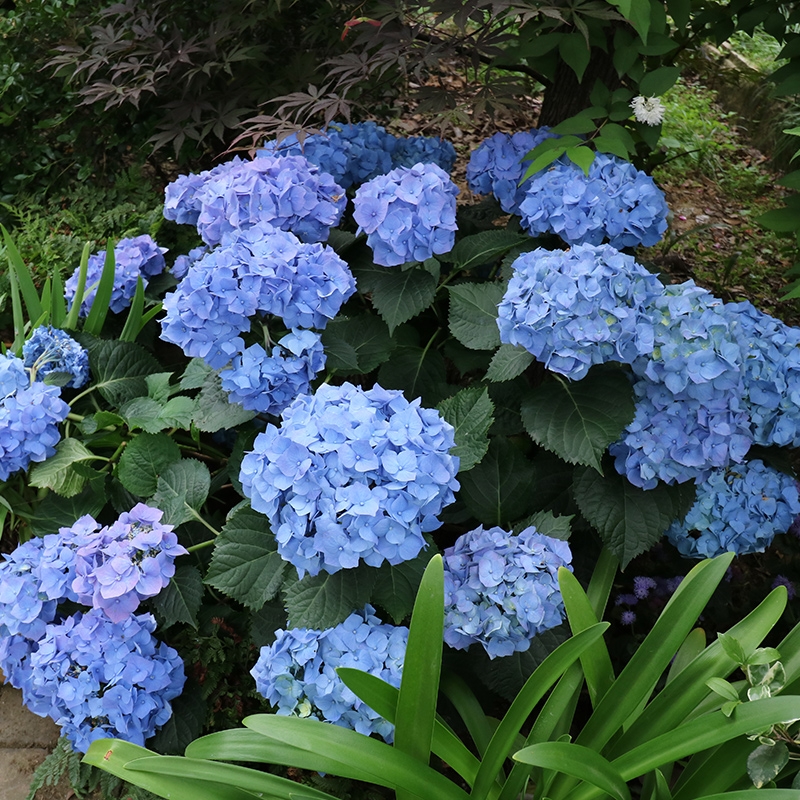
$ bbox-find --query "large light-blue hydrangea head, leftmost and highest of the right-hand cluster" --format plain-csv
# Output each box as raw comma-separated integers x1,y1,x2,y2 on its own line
497,245,664,380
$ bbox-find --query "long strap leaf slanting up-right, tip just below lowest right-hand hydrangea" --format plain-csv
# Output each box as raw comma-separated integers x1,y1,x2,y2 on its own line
575,553,733,756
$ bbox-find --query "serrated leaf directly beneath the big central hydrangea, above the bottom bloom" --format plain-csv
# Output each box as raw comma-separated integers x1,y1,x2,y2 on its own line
284,567,378,630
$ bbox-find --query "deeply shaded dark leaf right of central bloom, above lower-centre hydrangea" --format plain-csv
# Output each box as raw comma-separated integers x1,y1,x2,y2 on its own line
458,439,535,526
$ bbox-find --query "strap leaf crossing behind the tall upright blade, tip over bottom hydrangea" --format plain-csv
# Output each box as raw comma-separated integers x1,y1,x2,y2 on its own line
336,667,485,786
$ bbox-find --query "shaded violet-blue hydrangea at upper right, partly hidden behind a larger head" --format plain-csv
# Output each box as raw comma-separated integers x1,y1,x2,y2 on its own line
467,126,557,214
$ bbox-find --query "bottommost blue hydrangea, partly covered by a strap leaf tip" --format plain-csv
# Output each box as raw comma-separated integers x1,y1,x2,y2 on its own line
251,605,408,742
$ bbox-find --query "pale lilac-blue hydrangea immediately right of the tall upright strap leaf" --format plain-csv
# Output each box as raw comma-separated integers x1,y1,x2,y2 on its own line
444,526,572,658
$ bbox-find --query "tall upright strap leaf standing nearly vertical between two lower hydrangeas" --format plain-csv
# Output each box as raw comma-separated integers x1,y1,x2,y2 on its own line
394,555,444,768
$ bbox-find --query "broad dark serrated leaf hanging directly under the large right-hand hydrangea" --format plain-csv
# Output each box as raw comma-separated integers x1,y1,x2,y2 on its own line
521,369,635,472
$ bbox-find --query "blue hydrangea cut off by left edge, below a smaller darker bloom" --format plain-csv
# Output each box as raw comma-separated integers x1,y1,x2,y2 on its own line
0,353,69,481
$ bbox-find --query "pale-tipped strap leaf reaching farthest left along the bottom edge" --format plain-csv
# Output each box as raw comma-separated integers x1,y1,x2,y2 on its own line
83,739,257,800
